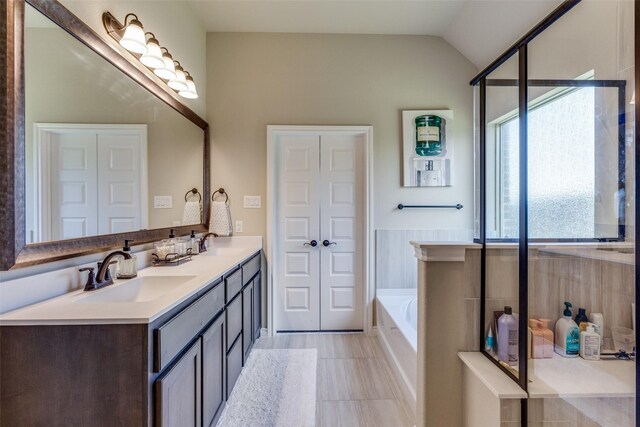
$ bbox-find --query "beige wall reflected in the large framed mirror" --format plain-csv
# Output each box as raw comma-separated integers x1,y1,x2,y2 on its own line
25,28,204,241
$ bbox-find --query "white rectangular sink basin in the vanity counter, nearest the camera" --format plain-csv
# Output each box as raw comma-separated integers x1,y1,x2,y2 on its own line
76,276,196,303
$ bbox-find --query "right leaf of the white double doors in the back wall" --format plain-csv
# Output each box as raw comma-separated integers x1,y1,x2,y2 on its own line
320,133,364,330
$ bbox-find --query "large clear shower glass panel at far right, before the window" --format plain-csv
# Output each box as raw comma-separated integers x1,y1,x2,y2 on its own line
524,1,636,426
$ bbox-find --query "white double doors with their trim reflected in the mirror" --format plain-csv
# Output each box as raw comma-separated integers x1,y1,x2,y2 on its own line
33,123,148,242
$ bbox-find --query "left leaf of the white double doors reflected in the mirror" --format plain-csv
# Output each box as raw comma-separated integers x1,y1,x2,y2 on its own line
50,132,98,240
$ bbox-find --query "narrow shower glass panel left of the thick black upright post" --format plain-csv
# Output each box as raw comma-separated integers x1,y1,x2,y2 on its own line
479,51,520,381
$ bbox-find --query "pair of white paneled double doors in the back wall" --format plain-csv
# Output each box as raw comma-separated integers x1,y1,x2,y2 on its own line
274,132,364,331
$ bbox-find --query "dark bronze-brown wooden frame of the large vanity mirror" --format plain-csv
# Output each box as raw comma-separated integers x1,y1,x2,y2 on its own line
0,0,210,271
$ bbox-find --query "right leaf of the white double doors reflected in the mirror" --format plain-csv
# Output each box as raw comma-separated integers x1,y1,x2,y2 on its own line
98,131,143,234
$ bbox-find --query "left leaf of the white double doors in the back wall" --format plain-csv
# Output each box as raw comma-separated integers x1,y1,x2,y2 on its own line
274,134,320,331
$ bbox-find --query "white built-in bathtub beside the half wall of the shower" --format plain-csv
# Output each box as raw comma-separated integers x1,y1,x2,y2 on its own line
376,289,418,412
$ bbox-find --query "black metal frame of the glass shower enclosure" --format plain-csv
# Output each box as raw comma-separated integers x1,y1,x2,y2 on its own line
470,0,640,425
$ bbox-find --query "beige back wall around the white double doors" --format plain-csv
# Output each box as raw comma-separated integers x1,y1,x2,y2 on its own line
207,33,477,235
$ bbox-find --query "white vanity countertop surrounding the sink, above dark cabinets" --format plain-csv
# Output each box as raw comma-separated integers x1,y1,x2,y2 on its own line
0,245,261,326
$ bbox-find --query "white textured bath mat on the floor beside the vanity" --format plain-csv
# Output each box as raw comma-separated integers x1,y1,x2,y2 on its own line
217,349,318,427
